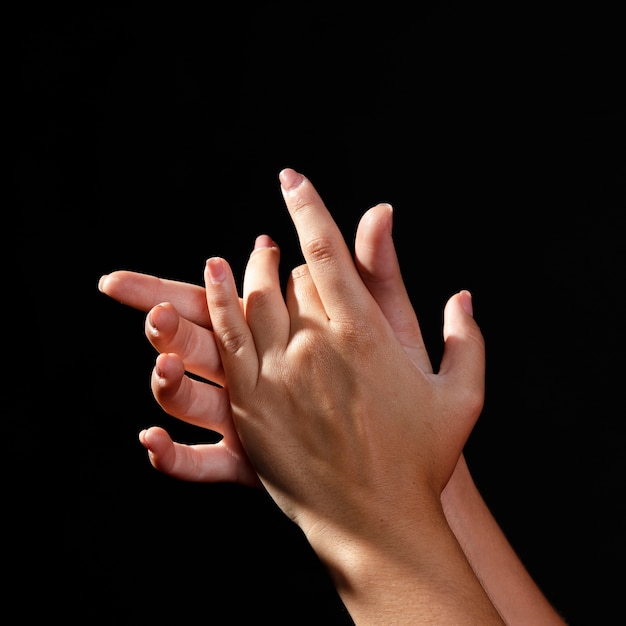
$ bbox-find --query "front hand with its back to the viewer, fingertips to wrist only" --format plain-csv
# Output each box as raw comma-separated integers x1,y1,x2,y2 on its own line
205,171,484,535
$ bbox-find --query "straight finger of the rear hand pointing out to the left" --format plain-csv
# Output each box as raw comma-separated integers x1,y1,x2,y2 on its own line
98,270,243,328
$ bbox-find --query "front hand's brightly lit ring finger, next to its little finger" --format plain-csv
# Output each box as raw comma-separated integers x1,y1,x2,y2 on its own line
243,235,289,354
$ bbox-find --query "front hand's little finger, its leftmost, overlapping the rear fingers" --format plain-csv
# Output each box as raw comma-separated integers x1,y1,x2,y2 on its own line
204,257,259,393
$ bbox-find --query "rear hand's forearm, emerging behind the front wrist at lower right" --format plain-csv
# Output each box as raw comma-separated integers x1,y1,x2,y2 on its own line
442,457,565,626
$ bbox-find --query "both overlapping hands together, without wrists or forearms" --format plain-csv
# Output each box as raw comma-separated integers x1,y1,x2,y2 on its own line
100,165,484,552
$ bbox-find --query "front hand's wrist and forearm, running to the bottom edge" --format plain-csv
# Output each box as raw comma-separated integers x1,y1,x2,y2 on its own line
298,497,502,626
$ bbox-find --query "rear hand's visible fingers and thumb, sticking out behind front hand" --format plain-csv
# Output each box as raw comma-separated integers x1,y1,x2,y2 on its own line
98,191,458,486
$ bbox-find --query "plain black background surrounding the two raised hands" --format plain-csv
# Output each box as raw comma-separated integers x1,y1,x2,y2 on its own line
17,2,625,625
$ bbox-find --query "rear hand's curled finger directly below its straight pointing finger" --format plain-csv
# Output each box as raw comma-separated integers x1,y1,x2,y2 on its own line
145,297,224,385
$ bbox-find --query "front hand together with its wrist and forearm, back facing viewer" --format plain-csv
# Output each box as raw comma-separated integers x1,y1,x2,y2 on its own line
197,170,502,624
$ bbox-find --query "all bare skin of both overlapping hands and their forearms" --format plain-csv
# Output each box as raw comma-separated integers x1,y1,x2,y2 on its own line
101,168,564,624
